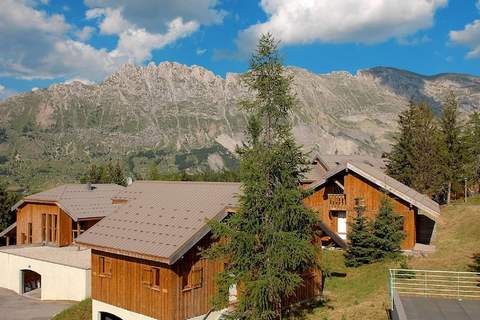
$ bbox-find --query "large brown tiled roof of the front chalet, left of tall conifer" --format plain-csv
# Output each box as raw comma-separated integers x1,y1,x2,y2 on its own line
76,181,240,264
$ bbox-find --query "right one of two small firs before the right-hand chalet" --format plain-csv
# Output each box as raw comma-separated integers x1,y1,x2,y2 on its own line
372,196,405,260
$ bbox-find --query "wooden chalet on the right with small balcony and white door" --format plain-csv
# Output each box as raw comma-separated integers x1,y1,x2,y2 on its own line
304,155,440,250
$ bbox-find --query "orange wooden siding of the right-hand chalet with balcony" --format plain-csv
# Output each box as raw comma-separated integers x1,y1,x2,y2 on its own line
304,172,417,249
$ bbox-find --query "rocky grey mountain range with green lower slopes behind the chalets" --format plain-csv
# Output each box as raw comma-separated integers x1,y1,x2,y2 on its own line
0,62,480,188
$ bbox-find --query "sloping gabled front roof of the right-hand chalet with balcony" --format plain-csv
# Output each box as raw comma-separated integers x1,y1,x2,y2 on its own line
309,161,440,220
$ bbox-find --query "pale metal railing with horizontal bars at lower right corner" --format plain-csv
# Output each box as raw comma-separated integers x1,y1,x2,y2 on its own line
389,269,480,305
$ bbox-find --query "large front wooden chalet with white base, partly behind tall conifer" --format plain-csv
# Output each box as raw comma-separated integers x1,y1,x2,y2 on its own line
76,181,328,320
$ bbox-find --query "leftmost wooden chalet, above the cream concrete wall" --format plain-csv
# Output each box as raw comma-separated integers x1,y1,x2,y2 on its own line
0,184,124,247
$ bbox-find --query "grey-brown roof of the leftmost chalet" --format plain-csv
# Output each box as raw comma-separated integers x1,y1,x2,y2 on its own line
12,184,124,221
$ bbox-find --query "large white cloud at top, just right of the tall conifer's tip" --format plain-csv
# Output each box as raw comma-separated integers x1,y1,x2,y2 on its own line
236,0,448,50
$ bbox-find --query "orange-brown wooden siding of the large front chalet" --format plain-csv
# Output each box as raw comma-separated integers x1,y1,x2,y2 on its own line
92,235,322,320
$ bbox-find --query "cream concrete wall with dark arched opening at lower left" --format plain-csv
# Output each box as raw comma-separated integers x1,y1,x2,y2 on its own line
0,252,90,301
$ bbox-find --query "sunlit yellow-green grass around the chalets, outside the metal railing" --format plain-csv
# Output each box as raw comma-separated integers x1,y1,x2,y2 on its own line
53,197,480,320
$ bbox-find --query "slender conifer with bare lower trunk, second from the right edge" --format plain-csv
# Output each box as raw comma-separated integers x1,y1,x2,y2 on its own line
440,92,465,203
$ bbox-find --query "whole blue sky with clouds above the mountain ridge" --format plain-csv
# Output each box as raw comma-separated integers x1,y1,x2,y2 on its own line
0,0,480,99
